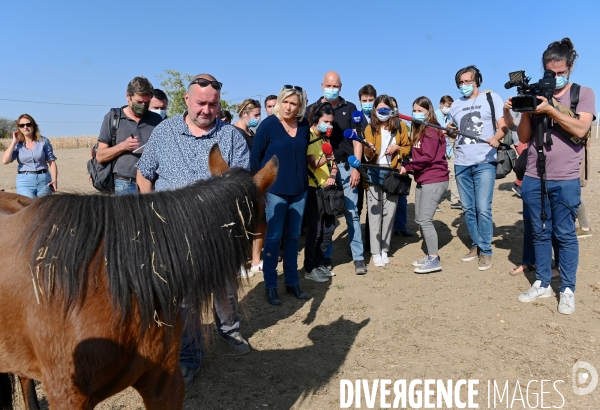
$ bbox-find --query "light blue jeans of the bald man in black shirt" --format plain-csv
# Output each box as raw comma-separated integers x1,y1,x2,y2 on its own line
336,162,365,261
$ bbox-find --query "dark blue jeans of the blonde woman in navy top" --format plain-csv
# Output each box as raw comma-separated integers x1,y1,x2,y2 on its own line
263,192,306,289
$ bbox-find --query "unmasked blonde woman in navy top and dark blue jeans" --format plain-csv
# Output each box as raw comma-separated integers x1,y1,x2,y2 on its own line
250,85,310,305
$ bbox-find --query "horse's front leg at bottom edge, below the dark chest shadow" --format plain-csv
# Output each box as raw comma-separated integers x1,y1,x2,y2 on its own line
133,366,185,410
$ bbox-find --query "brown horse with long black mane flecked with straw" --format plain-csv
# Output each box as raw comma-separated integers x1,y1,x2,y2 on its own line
0,145,277,410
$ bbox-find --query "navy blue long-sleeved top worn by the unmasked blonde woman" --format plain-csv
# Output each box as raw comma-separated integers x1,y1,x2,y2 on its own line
250,115,310,195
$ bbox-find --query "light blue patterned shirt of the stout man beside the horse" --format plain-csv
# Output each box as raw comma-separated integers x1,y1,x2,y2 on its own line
136,112,250,191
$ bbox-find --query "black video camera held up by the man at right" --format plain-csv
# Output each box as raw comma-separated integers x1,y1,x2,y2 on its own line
504,70,556,112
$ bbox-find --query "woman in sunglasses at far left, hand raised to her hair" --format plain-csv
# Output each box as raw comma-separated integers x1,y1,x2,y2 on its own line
2,114,58,198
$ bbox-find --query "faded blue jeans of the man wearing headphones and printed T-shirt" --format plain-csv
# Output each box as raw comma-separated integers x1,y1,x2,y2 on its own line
454,162,496,256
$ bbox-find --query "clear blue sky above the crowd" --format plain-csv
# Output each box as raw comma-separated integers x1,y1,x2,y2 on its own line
0,0,600,137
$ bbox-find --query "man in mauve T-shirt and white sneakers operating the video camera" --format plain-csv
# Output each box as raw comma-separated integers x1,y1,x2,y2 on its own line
518,38,596,315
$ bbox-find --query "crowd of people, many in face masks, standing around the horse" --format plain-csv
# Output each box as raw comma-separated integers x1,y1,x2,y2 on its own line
2,39,595,387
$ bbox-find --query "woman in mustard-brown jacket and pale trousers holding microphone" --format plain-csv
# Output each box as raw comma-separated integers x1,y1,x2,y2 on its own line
365,94,410,267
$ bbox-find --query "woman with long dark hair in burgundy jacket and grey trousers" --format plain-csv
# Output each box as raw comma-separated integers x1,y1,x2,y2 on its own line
400,97,449,273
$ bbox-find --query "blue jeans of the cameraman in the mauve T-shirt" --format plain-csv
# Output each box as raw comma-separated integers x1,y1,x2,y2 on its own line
524,176,581,292
